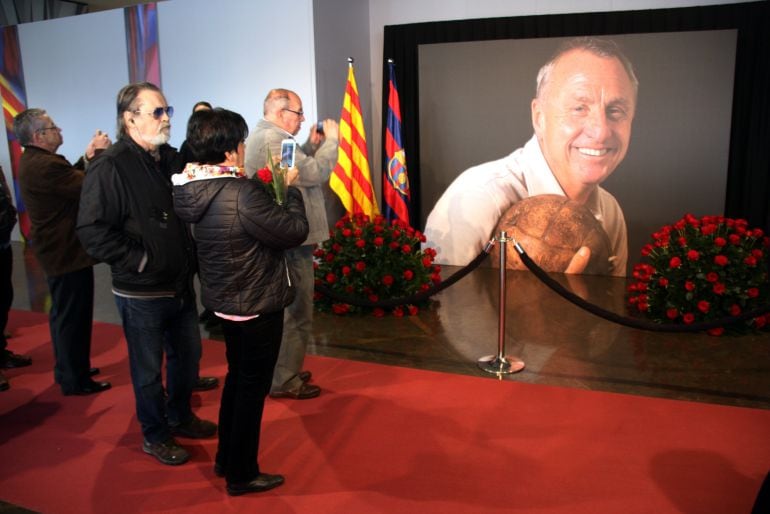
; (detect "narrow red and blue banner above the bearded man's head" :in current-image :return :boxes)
[125,3,161,87]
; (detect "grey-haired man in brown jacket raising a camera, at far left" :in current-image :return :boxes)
[13,109,110,396]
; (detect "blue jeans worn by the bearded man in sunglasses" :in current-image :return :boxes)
[115,294,201,443]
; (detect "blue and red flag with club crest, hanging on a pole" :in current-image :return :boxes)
[382,61,411,224]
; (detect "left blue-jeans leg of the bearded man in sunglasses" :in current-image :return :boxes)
[115,295,175,444]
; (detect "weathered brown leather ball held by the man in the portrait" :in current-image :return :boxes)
[491,195,611,275]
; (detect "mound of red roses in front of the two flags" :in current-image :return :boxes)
[314,210,441,317]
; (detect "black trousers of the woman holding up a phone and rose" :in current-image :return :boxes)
[216,310,283,484]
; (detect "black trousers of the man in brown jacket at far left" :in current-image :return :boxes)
[47,266,94,393]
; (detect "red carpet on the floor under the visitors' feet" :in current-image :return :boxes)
[0,311,770,514]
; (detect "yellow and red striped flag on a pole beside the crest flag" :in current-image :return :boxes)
[329,60,380,217]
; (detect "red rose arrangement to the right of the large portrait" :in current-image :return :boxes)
[628,214,770,335]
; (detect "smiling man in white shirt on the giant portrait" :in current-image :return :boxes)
[425,38,638,276]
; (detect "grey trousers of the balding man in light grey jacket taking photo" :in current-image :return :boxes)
[271,245,315,393]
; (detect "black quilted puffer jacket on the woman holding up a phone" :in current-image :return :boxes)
[174,167,308,316]
